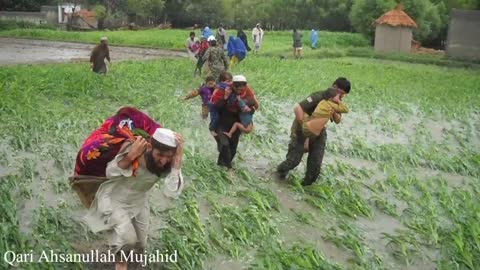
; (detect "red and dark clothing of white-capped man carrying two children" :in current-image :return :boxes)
[212,86,258,168]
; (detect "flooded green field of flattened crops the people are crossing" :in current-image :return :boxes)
[0,57,480,270]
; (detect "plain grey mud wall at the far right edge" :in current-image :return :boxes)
[446,9,480,60]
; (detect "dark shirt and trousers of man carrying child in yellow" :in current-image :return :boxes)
[277,89,337,185]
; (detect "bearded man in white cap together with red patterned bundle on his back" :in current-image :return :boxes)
[70,107,184,270]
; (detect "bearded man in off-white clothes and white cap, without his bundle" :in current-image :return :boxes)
[79,128,184,270]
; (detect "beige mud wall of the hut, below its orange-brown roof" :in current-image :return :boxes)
[375,24,412,52]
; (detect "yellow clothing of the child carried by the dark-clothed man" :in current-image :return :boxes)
[302,100,348,138]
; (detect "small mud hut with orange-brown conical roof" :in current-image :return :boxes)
[375,4,417,52]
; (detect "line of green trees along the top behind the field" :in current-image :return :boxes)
[0,0,480,46]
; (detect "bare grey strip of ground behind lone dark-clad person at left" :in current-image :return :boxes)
[0,38,187,65]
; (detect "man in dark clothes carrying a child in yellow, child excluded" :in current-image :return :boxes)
[277,77,350,186]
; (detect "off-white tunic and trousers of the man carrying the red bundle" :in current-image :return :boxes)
[85,146,183,252]
